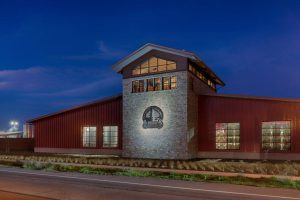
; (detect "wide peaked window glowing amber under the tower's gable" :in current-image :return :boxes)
[132,57,176,75]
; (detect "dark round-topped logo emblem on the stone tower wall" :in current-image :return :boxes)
[143,106,164,129]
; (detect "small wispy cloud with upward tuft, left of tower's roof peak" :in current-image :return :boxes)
[63,41,126,61]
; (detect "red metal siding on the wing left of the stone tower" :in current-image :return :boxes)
[31,97,122,149]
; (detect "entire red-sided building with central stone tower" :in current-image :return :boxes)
[26,44,300,160]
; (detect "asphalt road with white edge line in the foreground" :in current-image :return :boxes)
[0,167,300,200]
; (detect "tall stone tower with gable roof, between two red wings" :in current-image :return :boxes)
[113,44,224,159]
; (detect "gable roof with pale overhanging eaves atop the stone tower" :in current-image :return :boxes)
[112,43,225,86]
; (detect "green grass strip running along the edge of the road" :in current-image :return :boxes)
[9,162,300,189]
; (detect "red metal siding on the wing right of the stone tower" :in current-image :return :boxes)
[198,96,300,153]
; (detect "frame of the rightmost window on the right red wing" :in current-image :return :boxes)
[260,119,293,153]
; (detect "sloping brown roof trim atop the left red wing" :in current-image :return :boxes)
[26,94,122,123]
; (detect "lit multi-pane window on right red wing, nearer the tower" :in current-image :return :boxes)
[216,123,240,150]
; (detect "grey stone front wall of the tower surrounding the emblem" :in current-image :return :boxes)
[123,71,193,159]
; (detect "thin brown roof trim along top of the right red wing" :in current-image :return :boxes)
[199,94,300,103]
